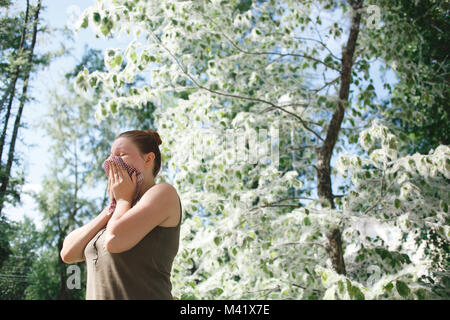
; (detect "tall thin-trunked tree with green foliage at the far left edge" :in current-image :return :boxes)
[0,0,52,214]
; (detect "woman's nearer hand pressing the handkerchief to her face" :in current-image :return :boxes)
[109,162,137,203]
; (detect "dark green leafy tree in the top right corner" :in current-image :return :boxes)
[374,0,450,154]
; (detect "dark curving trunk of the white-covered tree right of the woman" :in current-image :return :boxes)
[316,0,363,275]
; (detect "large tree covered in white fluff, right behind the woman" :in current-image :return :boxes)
[76,0,448,299]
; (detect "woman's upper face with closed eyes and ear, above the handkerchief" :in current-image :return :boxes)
[111,137,153,173]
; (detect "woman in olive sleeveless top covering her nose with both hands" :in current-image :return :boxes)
[60,130,182,300]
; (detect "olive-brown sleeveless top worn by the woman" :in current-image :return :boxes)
[84,196,183,300]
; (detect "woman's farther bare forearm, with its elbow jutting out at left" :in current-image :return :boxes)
[60,207,111,263]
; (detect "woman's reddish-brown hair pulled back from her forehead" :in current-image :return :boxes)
[116,130,162,177]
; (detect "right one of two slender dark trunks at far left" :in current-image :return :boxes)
[0,0,41,215]
